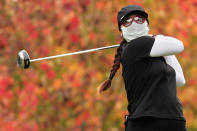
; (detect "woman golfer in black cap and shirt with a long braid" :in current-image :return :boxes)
[99,5,186,131]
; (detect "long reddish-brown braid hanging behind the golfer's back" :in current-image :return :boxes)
[98,40,126,93]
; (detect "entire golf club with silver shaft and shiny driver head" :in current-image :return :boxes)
[17,44,119,69]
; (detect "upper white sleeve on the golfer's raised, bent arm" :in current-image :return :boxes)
[150,35,184,57]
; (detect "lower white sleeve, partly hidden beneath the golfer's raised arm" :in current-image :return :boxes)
[164,55,185,86]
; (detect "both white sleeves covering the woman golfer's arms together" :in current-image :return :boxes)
[150,35,185,86]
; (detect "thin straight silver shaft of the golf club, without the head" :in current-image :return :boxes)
[30,44,119,62]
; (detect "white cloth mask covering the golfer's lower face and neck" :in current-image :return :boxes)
[121,21,149,42]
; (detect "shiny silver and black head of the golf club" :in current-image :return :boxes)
[17,50,30,69]
